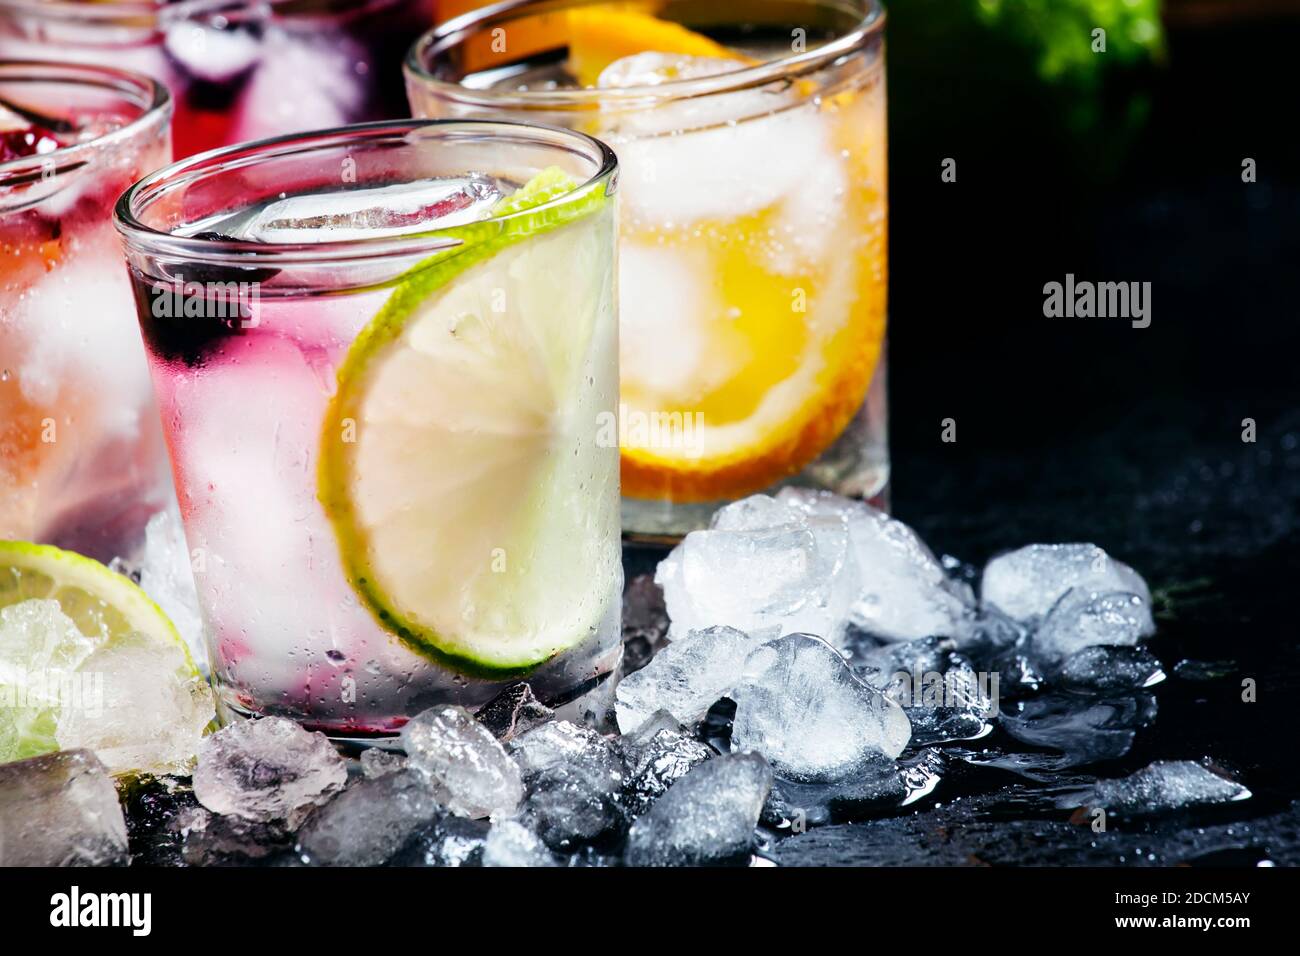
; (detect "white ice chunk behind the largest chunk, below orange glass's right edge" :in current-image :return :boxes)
[776,488,975,641]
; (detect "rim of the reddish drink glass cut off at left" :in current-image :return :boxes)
[0,60,173,189]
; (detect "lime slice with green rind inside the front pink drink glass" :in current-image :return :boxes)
[319,169,621,678]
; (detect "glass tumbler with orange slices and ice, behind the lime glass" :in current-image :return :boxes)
[406,0,889,538]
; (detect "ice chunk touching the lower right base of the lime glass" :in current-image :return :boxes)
[614,627,762,734]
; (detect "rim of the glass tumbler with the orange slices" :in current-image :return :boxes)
[402,0,885,109]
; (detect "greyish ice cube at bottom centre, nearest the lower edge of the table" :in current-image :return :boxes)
[624,753,772,866]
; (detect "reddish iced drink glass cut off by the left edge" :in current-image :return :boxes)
[0,61,172,561]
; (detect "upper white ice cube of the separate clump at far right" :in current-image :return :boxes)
[980,544,1156,636]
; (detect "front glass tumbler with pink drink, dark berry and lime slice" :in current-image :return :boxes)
[117,121,623,739]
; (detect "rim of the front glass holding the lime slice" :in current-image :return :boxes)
[113,120,619,267]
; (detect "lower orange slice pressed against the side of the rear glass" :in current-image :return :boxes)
[620,204,885,502]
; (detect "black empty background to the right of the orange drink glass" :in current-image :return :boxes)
[863,0,1300,862]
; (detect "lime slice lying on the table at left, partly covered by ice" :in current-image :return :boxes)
[0,541,203,762]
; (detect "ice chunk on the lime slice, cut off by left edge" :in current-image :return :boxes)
[0,598,95,763]
